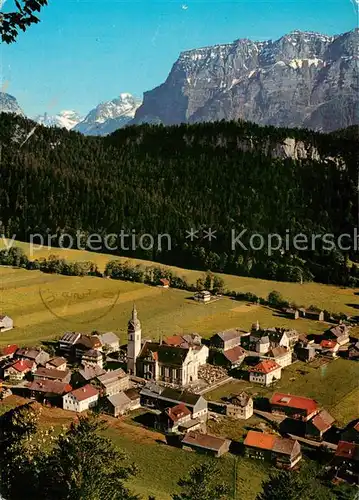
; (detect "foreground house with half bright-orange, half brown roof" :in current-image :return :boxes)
[244,431,302,469]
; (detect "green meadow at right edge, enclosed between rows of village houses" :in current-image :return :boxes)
[206,358,359,426]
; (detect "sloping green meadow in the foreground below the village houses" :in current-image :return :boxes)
[0,396,271,500]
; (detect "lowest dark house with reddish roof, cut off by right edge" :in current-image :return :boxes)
[332,441,359,483]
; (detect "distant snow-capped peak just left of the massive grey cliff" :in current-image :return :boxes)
[74,93,141,135]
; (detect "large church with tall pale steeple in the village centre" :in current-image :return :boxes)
[127,306,209,387]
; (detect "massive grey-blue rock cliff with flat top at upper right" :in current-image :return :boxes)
[134,29,359,131]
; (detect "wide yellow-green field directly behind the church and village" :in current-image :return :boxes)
[0,267,353,345]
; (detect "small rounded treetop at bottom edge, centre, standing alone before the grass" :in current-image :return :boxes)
[172,462,229,500]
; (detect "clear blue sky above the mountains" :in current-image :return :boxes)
[0,0,358,116]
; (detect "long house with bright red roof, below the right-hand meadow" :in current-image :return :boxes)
[270,392,319,422]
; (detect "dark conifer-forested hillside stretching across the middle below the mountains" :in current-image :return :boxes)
[0,114,358,286]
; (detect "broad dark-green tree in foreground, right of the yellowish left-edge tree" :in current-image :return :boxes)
[42,415,138,500]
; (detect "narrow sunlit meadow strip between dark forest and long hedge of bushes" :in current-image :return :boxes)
[0,240,359,314]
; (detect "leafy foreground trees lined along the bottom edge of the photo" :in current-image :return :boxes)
[0,403,356,500]
